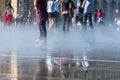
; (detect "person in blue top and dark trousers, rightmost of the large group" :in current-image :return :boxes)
[82,0,94,29]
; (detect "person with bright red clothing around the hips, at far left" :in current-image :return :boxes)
[2,2,14,25]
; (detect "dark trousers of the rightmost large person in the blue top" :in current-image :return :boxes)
[83,13,94,28]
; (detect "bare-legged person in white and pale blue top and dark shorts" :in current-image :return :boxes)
[47,0,55,29]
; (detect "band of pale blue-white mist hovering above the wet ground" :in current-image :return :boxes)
[0,25,120,56]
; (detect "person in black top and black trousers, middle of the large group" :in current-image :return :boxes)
[61,0,75,32]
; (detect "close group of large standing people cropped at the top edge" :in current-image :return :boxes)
[34,0,94,42]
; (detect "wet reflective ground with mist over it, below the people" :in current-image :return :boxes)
[0,27,120,80]
